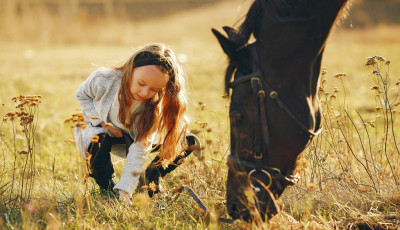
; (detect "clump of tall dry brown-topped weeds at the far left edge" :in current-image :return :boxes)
[0,95,42,211]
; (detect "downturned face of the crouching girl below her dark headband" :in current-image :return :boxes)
[130,65,169,101]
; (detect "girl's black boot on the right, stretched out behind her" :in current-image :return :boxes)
[139,134,201,197]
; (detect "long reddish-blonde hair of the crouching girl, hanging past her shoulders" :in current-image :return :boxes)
[114,43,189,161]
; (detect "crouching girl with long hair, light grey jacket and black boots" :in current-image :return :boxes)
[75,44,200,204]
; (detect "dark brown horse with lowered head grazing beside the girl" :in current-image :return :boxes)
[213,0,347,221]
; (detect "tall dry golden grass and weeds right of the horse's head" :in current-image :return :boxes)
[283,56,400,229]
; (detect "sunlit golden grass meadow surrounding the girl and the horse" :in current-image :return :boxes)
[0,0,400,229]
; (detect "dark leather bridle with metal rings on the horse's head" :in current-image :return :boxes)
[228,47,322,191]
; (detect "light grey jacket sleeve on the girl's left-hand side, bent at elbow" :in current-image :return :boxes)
[75,71,105,126]
